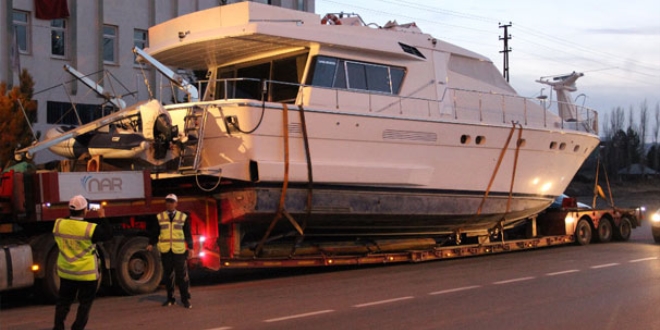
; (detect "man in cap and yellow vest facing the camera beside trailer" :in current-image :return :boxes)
[147,194,193,308]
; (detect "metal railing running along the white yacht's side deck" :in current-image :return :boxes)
[191,78,598,134]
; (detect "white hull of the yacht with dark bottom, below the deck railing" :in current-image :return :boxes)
[164,101,599,235]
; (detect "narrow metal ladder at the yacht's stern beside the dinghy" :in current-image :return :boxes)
[179,106,208,173]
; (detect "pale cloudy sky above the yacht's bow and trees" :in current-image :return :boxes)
[315,0,660,133]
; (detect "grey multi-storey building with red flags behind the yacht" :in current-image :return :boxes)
[0,0,314,163]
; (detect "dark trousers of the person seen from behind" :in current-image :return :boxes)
[53,278,97,330]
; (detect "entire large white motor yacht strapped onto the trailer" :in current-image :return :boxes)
[20,2,599,244]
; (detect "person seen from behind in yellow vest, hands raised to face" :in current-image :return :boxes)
[53,195,112,330]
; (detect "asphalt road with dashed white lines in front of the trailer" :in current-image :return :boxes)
[0,224,660,330]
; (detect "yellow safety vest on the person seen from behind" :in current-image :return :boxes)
[53,219,99,281]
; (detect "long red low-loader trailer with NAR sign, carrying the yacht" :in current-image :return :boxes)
[0,171,641,299]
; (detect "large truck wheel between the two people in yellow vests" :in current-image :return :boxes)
[115,237,163,295]
